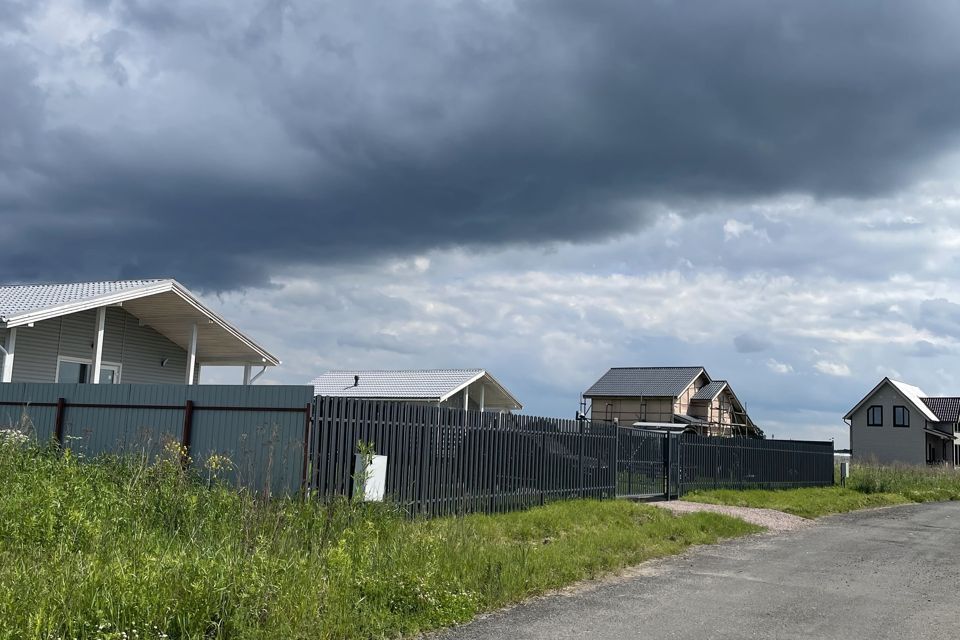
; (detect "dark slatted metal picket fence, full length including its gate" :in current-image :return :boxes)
[308,397,833,515]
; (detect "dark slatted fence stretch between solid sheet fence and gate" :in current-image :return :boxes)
[309,398,617,515]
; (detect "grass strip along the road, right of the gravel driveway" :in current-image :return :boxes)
[683,465,960,518]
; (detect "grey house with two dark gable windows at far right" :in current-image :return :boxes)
[843,378,960,467]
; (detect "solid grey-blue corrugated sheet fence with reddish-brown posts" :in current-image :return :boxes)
[0,383,313,493]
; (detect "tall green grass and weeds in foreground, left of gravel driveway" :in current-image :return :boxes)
[0,442,757,640]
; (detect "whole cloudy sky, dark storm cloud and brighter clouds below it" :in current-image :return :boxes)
[0,0,960,445]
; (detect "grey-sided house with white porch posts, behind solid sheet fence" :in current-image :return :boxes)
[0,279,280,384]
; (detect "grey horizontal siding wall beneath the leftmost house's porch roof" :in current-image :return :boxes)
[13,307,187,384]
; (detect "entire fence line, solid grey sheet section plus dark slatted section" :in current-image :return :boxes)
[0,383,833,508]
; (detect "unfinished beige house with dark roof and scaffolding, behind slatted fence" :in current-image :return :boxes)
[583,367,763,437]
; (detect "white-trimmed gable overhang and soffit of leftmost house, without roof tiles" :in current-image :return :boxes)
[0,279,280,366]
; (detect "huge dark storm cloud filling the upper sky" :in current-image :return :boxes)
[0,0,960,289]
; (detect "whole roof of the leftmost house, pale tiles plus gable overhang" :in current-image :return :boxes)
[0,279,280,366]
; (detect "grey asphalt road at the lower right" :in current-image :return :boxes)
[439,502,960,640]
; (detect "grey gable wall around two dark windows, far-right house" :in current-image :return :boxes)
[850,384,927,464]
